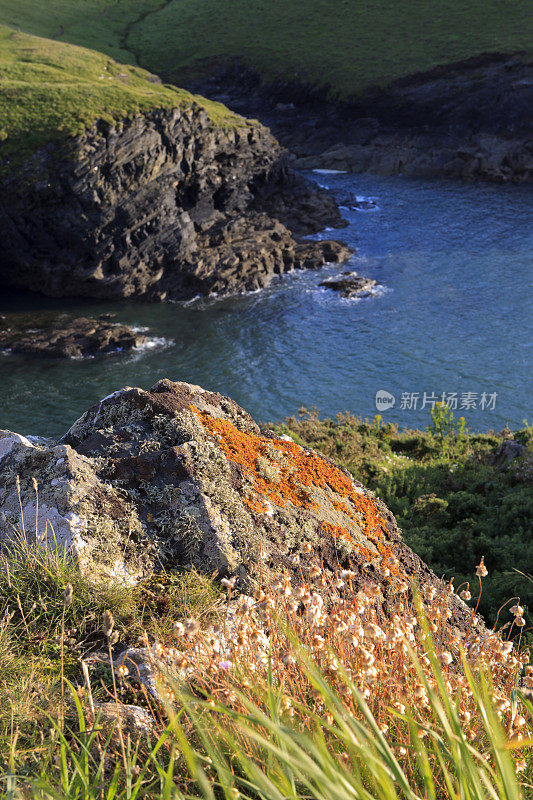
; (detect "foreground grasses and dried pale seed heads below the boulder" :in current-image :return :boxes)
[0,528,533,800]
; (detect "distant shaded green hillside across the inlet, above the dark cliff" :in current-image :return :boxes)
[0,0,533,101]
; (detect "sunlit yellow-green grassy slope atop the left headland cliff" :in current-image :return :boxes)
[0,27,238,164]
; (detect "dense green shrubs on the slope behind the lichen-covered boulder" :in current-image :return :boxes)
[277,406,533,624]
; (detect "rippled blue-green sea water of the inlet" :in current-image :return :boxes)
[0,174,533,435]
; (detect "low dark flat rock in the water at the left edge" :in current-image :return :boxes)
[0,315,147,358]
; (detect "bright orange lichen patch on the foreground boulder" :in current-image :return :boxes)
[191,405,400,576]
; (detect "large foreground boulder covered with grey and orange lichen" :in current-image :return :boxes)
[0,380,444,588]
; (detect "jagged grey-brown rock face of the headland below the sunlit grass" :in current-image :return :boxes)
[0,103,348,300]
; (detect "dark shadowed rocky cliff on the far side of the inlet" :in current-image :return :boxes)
[196,53,533,183]
